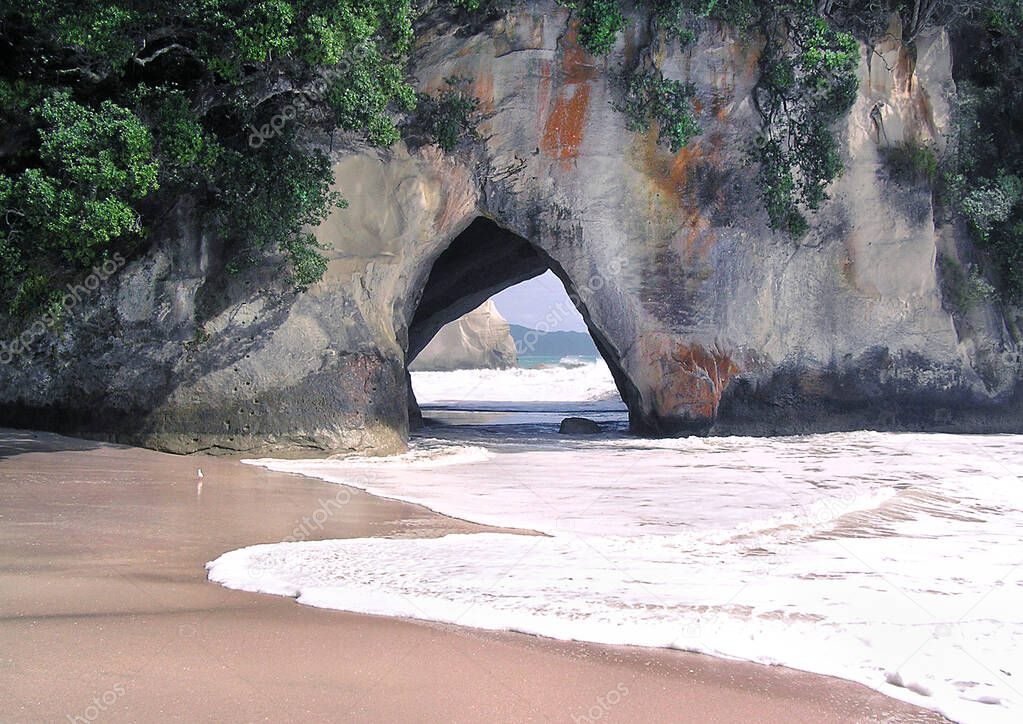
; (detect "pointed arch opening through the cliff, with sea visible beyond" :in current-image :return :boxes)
[406,217,628,429]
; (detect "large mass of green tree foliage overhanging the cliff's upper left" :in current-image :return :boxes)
[0,0,415,319]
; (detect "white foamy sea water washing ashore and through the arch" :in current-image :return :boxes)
[209,363,1023,722]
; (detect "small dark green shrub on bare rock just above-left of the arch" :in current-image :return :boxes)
[403,77,481,152]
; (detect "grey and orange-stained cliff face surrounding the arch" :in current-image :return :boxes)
[0,2,1021,452]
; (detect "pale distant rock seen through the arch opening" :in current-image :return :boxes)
[409,300,518,370]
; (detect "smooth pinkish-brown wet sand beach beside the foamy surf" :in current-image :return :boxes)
[0,429,943,722]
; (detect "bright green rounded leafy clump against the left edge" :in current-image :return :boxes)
[0,92,159,314]
